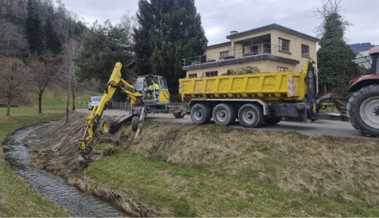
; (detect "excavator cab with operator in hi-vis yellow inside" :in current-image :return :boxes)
[134,75,170,112]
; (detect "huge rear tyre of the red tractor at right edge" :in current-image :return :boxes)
[348,85,379,136]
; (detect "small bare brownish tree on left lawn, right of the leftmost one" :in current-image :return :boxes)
[28,54,61,114]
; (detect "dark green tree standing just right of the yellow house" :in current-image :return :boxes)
[318,0,357,93]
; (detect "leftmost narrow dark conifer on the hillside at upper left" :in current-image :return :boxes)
[25,0,44,55]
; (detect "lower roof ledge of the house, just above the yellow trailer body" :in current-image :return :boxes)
[184,54,299,70]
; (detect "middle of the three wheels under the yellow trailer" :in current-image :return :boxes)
[213,104,237,126]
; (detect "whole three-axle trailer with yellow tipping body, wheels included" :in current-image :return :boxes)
[179,64,317,128]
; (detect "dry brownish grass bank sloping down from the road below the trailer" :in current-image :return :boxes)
[128,121,379,204]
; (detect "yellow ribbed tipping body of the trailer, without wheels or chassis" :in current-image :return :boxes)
[180,72,306,101]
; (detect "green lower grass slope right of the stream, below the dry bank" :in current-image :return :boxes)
[85,150,379,217]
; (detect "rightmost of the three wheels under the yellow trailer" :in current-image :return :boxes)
[238,104,263,128]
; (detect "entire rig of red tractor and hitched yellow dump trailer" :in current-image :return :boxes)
[180,48,379,136]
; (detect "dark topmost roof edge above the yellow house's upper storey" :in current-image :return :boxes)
[227,23,320,42]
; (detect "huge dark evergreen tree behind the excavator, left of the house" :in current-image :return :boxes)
[134,0,207,94]
